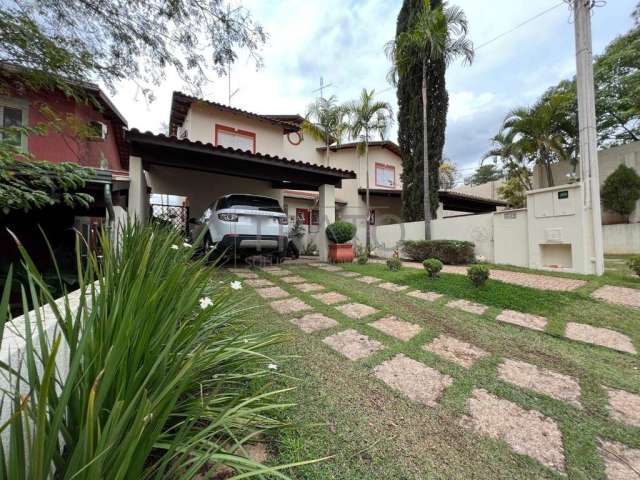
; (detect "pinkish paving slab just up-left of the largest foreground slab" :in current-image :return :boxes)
[374,354,453,407]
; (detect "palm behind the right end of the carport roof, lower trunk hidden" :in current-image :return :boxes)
[302,95,347,166]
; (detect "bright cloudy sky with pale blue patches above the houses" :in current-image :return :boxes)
[114,0,637,180]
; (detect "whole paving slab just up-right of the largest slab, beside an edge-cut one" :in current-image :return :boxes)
[498,359,582,408]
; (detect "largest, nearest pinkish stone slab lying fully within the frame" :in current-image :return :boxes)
[462,389,564,472]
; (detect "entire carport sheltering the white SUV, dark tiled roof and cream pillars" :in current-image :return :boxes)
[127,129,356,260]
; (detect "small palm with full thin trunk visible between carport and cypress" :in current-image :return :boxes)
[348,88,393,252]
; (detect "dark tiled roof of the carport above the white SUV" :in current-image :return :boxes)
[127,129,356,190]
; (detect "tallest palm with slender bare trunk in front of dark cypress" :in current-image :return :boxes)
[386,0,474,240]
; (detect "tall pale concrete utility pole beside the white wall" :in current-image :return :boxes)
[572,0,604,275]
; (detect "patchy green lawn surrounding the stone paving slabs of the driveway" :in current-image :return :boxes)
[232,264,640,479]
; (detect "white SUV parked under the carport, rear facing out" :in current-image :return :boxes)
[194,193,289,262]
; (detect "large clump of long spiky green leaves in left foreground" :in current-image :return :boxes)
[0,225,310,480]
